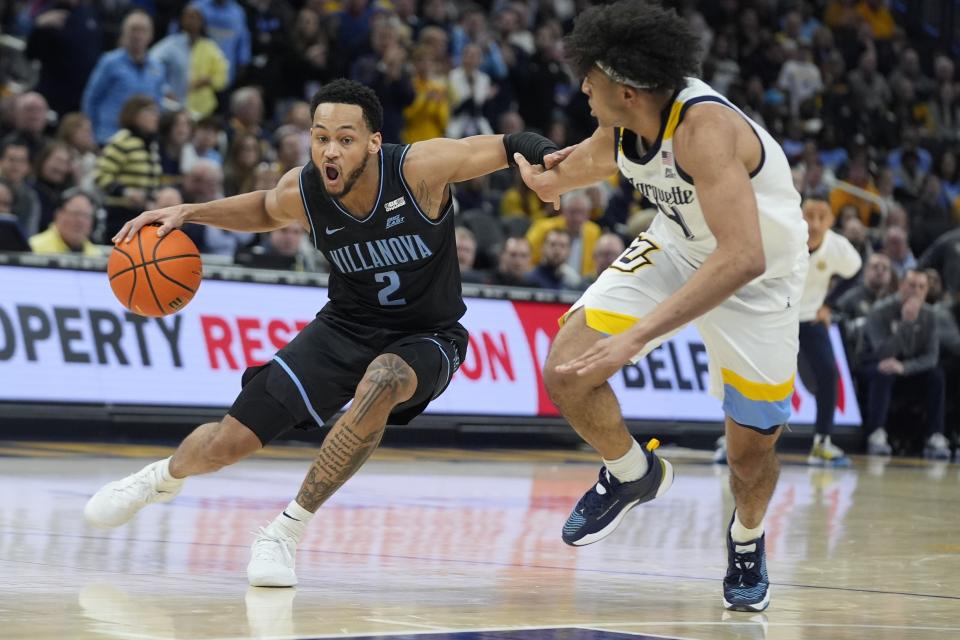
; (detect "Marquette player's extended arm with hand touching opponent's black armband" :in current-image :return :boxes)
[516,127,617,209]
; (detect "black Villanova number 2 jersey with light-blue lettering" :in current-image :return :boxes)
[300,144,466,331]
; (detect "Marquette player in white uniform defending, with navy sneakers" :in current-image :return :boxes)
[518,0,807,611]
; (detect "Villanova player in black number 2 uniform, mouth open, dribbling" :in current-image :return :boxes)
[84,80,556,586]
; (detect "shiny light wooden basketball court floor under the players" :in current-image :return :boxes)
[0,442,960,640]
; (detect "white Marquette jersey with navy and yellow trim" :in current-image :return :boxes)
[616,78,807,279]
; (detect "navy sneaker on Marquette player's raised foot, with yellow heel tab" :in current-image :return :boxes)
[563,438,673,547]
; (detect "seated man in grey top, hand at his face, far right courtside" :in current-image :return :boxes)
[864,269,950,460]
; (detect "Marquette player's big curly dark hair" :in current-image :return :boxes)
[564,0,701,89]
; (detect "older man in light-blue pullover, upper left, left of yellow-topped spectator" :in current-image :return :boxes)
[83,11,164,145]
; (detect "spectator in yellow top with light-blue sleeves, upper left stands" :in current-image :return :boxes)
[150,4,230,118]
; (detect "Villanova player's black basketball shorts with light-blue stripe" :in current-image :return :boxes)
[229,312,467,444]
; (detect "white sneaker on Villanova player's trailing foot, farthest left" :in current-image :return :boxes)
[83,460,183,529]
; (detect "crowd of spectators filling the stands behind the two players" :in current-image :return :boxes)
[0,0,960,456]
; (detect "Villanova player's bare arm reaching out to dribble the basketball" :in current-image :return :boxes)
[113,167,309,244]
